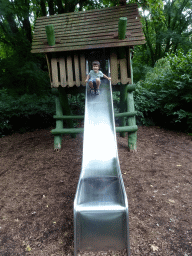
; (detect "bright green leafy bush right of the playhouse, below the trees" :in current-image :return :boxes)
[135,50,192,132]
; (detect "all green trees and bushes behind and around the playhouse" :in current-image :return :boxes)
[0,0,192,135]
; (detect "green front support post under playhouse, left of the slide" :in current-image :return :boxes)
[52,88,63,151]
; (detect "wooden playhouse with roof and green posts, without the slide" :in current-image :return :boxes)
[32,4,145,150]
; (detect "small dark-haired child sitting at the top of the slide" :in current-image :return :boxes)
[85,61,111,95]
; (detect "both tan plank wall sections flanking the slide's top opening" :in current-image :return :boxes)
[50,48,131,87]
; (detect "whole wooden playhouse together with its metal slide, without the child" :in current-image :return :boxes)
[32,4,145,256]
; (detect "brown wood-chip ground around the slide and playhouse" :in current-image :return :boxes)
[0,127,192,256]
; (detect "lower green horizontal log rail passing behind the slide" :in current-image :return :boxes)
[51,125,138,135]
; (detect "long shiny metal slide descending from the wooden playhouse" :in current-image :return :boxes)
[74,61,129,256]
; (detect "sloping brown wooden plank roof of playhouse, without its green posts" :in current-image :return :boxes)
[31,4,145,53]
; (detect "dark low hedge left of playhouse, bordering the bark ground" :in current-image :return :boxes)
[0,89,55,136]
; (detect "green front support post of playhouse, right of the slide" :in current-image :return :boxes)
[127,50,137,152]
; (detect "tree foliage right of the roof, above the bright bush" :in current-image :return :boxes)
[131,0,192,67]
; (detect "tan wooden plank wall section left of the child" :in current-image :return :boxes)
[50,54,86,87]
